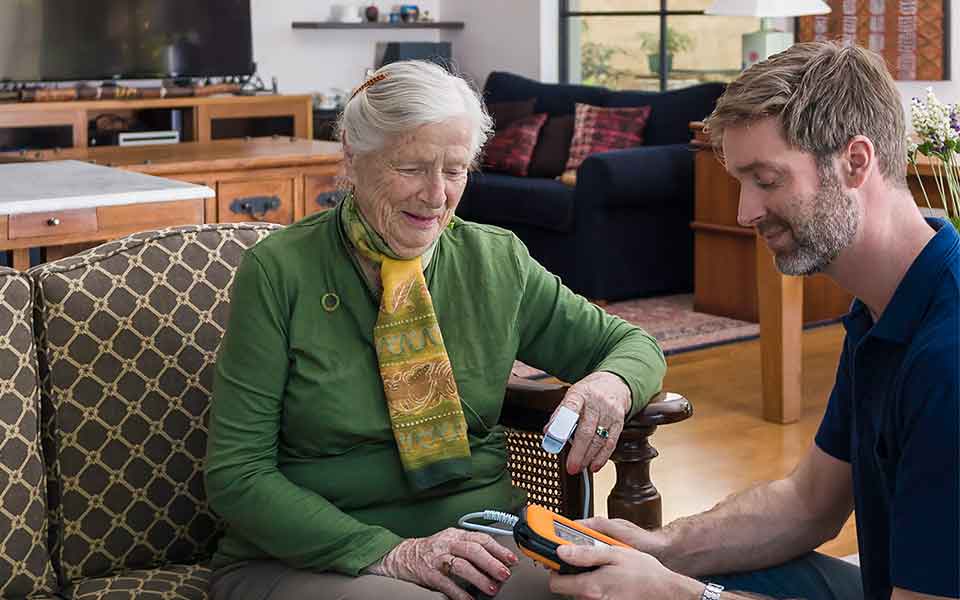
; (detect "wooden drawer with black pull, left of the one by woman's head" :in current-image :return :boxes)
[217,179,293,225]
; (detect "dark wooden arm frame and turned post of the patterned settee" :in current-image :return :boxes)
[501,377,693,529]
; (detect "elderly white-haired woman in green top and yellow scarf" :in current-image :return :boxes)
[206,62,665,600]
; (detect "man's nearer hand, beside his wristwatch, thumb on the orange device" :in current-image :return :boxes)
[550,545,704,600]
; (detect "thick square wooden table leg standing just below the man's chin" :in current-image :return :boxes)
[756,236,803,423]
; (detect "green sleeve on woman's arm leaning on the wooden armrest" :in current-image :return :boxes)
[515,240,667,416]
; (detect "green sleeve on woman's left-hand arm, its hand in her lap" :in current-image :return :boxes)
[205,249,402,575]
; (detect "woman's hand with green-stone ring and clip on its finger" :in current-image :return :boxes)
[543,371,631,475]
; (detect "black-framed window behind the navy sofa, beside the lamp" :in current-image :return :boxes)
[560,0,760,91]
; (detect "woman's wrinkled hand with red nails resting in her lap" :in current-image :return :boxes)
[366,527,517,600]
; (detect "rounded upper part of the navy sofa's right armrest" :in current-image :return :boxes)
[577,144,694,210]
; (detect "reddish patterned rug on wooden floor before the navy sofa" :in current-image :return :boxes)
[513,294,760,379]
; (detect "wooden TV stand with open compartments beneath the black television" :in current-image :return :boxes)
[0,95,313,151]
